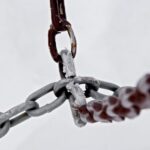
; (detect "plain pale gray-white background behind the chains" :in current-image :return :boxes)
[0,0,150,150]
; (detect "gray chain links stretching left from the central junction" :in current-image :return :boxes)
[0,83,66,138]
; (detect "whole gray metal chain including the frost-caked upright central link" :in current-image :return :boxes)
[0,50,119,138]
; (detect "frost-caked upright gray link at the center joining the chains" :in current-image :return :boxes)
[59,50,86,127]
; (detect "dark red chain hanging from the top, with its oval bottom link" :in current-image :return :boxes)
[48,0,77,62]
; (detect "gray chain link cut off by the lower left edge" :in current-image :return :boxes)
[0,113,10,138]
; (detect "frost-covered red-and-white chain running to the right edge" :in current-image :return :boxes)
[78,74,150,123]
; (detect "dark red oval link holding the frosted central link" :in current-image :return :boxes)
[48,24,77,62]
